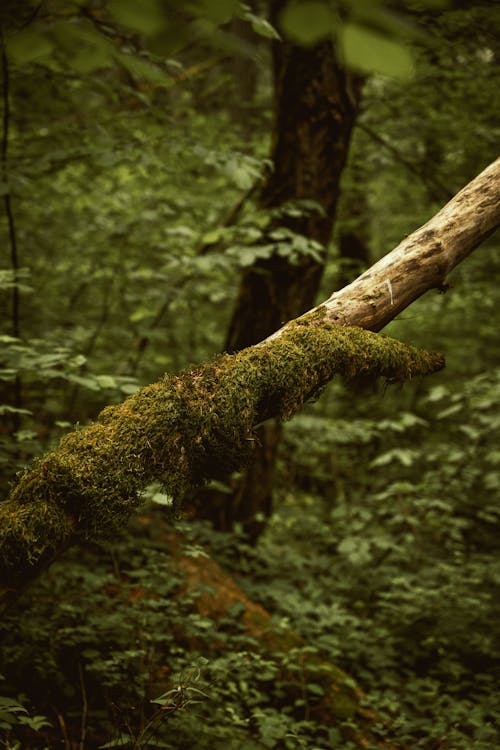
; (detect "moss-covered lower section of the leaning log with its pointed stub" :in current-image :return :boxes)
[0,322,443,601]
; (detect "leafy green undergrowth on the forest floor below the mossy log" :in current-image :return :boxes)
[0,372,500,750]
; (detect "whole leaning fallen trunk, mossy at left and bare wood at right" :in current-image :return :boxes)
[0,159,500,604]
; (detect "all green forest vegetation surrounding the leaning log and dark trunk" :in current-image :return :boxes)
[0,0,500,750]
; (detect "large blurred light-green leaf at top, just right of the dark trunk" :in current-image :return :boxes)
[340,23,413,79]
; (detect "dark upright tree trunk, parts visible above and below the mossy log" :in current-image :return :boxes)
[197,25,361,538]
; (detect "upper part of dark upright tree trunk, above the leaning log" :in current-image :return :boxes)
[226,42,360,352]
